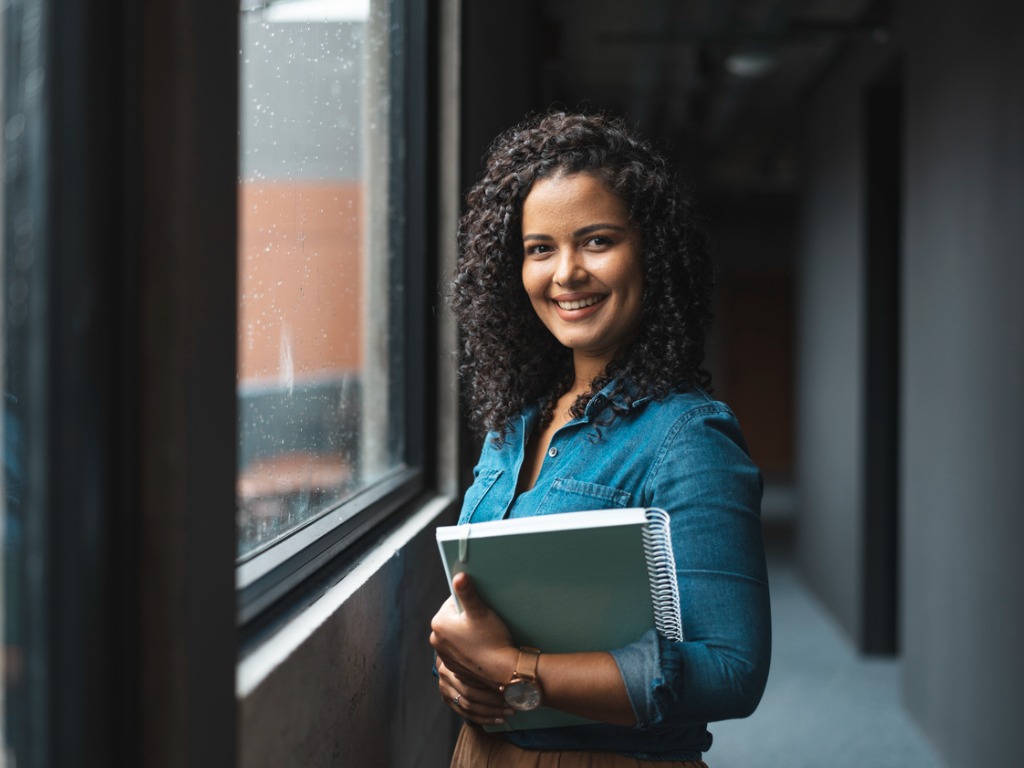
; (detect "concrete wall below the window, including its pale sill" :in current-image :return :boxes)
[238,502,458,768]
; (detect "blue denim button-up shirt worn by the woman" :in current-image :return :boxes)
[459,385,771,761]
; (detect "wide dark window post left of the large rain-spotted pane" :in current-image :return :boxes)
[4,0,239,768]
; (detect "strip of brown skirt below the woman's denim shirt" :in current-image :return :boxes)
[452,724,708,768]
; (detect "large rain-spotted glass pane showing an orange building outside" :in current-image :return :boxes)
[238,0,403,558]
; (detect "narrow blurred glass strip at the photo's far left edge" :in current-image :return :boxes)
[0,0,42,766]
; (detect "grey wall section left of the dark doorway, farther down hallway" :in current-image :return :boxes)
[797,45,880,651]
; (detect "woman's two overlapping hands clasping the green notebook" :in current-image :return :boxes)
[430,573,518,724]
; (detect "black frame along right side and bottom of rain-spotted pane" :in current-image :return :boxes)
[236,0,437,626]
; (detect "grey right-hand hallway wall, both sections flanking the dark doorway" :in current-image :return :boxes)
[798,0,1024,765]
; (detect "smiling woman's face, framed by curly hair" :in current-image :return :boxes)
[522,173,643,369]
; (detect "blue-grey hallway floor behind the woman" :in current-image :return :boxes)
[705,547,946,768]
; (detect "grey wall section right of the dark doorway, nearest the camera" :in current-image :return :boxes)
[901,0,1024,765]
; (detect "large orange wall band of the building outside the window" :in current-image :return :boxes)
[239,181,365,382]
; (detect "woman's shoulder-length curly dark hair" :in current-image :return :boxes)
[449,112,713,442]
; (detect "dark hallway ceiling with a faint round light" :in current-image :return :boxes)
[540,0,892,191]
